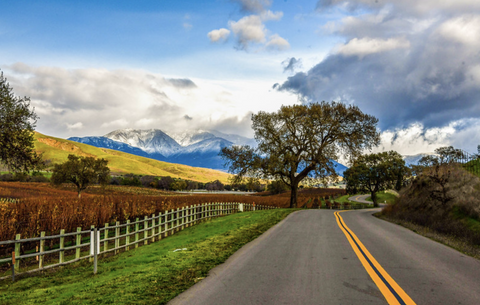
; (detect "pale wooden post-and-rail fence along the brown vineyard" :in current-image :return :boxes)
[0,203,277,280]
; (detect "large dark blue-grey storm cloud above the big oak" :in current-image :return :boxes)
[276,0,480,129]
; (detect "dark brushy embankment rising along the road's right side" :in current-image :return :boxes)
[380,147,480,258]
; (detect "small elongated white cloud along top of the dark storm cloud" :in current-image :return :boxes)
[337,37,410,58]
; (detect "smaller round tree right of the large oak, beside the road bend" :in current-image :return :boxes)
[343,151,409,206]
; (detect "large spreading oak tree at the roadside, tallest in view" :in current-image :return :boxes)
[220,102,379,207]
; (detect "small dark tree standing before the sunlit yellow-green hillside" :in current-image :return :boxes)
[51,155,110,198]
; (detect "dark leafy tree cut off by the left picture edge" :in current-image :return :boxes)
[0,72,41,172]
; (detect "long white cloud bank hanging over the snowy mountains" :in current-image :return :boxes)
[2,64,296,138]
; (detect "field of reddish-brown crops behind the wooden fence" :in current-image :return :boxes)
[0,182,344,240]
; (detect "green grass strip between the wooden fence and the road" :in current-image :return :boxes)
[0,209,295,305]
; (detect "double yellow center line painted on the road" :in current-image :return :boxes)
[334,211,415,305]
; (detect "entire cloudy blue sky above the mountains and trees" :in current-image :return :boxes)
[0,0,480,155]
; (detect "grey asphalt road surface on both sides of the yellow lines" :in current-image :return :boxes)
[171,209,480,305]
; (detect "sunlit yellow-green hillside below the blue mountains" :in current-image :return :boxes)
[35,132,230,183]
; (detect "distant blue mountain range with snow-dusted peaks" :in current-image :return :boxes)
[68,129,347,175]
